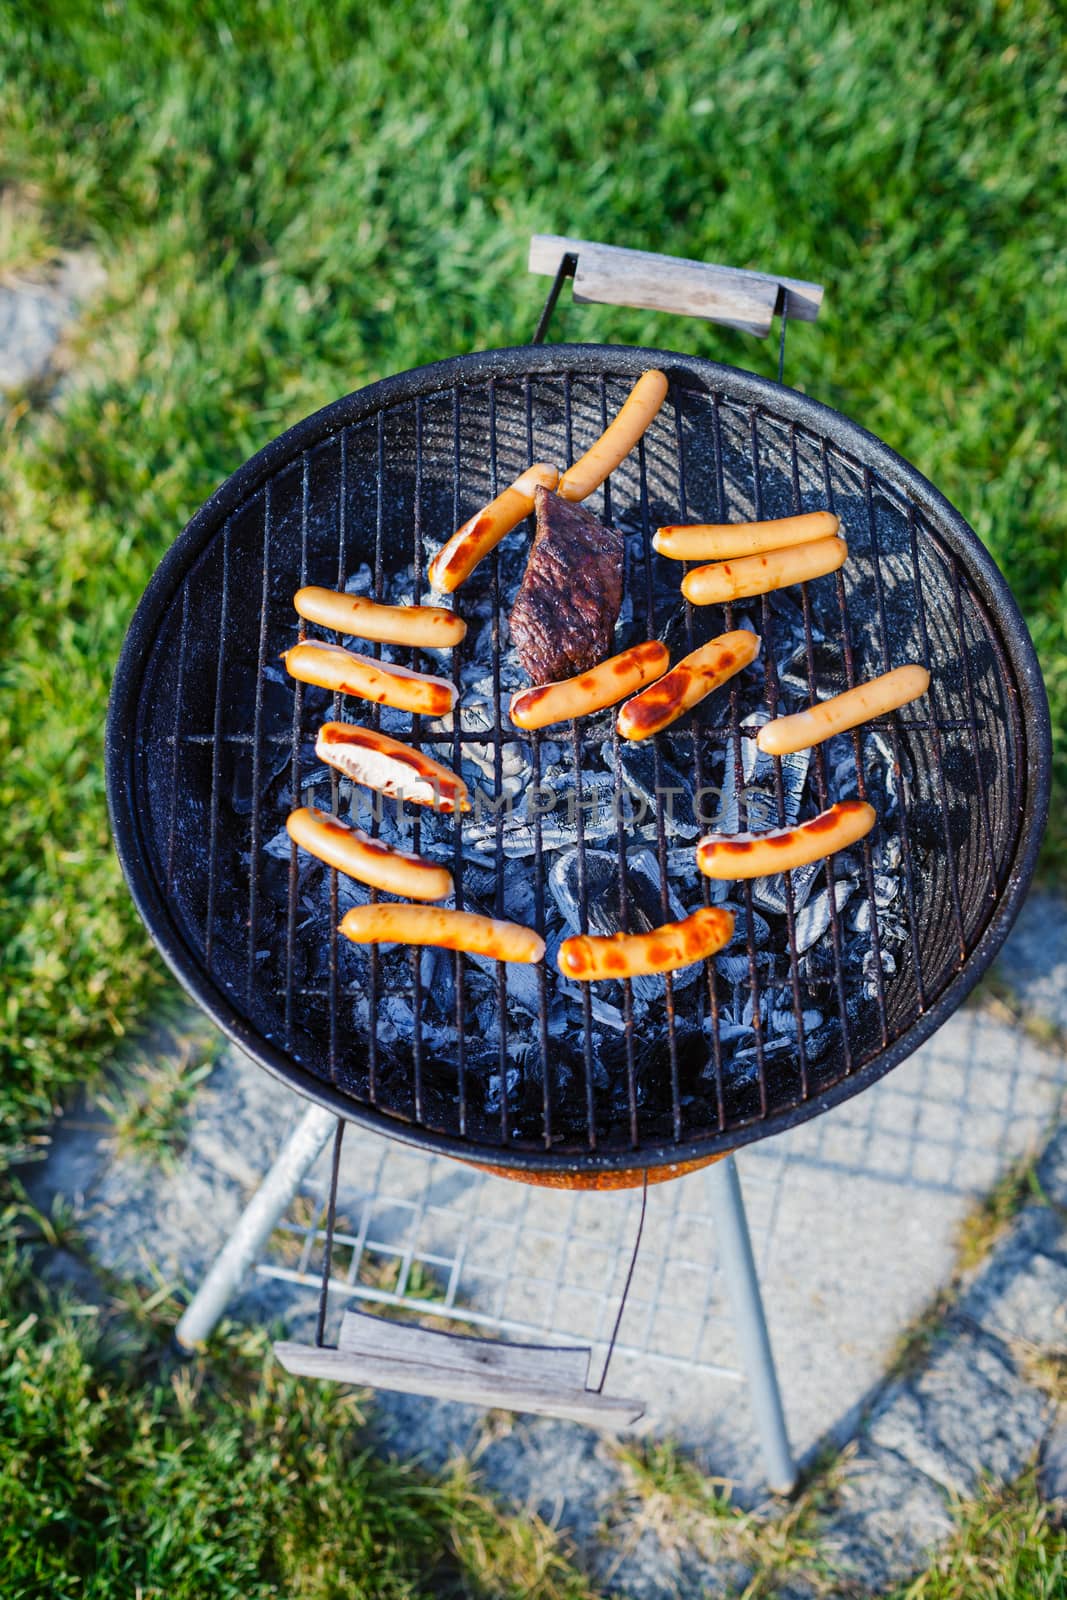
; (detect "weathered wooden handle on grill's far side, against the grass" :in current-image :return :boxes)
[530,234,822,339]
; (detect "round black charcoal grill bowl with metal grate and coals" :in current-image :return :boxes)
[107,240,1051,1484]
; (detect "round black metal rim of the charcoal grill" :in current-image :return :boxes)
[104,344,1053,1174]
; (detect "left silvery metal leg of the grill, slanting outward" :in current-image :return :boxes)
[174,1106,338,1354]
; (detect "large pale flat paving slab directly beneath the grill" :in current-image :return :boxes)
[33,1011,1067,1510]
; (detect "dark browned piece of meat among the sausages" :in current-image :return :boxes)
[510,488,622,683]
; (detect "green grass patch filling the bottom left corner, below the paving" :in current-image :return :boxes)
[0,1219,589,1600]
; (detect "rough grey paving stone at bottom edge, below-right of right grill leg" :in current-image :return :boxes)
[812,1442,953,1592]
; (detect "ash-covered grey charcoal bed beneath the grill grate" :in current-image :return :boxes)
[254,518,910,1132]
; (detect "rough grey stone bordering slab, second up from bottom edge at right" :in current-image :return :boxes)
[867,1320,1049,1498]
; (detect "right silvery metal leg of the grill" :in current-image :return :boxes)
[704,1155,797,1494]
